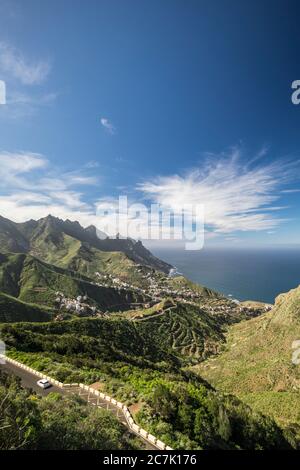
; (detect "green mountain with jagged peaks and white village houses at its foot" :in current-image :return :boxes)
[0,216,220,320]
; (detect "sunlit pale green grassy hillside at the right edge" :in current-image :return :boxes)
[196,287,300,434]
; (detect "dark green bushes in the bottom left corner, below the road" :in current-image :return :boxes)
[0,371,140,450]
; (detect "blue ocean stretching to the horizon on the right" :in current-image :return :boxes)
[151,247,300,303]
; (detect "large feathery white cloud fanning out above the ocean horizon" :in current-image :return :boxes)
[138,148,298,233]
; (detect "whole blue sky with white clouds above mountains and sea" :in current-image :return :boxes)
[0,0,300,245]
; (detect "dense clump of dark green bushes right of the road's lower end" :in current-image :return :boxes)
[138,382,291,450]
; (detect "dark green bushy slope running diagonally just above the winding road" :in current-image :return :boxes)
[2,318,295,449]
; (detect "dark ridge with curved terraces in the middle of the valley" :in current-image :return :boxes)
[1,300,229,370]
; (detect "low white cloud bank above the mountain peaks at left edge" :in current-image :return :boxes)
[0,152,97,225]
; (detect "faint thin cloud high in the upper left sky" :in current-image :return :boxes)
[0,42,51,85]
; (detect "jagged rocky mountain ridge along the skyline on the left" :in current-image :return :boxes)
[0,215,172,273]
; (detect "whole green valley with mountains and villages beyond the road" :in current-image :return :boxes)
[0,216,300,449]
